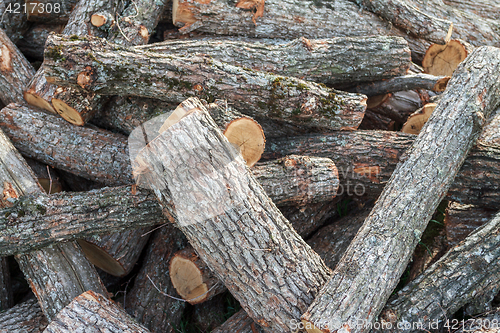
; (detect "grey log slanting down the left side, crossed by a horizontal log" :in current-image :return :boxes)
[0,127,107,320]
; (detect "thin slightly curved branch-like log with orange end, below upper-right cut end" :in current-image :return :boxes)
[349,74,450,96]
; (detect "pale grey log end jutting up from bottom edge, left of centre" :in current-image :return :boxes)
[44,291,150,333]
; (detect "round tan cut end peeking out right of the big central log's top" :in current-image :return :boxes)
[224,117,266,167]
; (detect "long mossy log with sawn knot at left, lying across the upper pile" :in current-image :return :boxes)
[43,35,366,129]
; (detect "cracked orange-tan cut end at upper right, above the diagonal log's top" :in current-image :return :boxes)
[422,40,468,76]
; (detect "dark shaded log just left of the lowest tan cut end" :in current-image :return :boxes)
[125,223,187,333]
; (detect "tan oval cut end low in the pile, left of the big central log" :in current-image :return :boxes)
[169,256,208,304]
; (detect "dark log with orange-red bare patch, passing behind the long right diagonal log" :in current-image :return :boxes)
[263,131,500,209]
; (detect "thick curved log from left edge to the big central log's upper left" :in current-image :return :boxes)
[0,104,133,185]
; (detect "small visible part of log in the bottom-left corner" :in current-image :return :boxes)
[0,299,48,333]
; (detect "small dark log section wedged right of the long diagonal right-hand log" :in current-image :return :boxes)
[444,202,495,246]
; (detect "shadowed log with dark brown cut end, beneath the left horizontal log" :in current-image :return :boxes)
[78,227,151,276]
